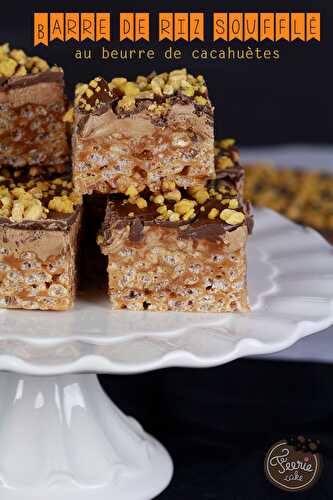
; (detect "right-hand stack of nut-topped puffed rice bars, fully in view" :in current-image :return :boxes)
[72,70,252,312]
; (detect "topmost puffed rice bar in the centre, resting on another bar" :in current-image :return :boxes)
[72,69,214,194]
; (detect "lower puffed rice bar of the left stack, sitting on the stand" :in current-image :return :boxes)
[0,167,82,310]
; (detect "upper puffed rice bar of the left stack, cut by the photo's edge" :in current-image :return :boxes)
[0,43,68,169]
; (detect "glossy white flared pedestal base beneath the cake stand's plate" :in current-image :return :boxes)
[0,373,173,500]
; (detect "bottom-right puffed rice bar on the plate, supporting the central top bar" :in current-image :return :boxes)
[98,180,252,312]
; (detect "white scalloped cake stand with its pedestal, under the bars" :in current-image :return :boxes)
[0,210,333,500]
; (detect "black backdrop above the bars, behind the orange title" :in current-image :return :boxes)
[0,0,333,145]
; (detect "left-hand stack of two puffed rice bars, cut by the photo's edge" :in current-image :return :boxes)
[0,44,82,310]
